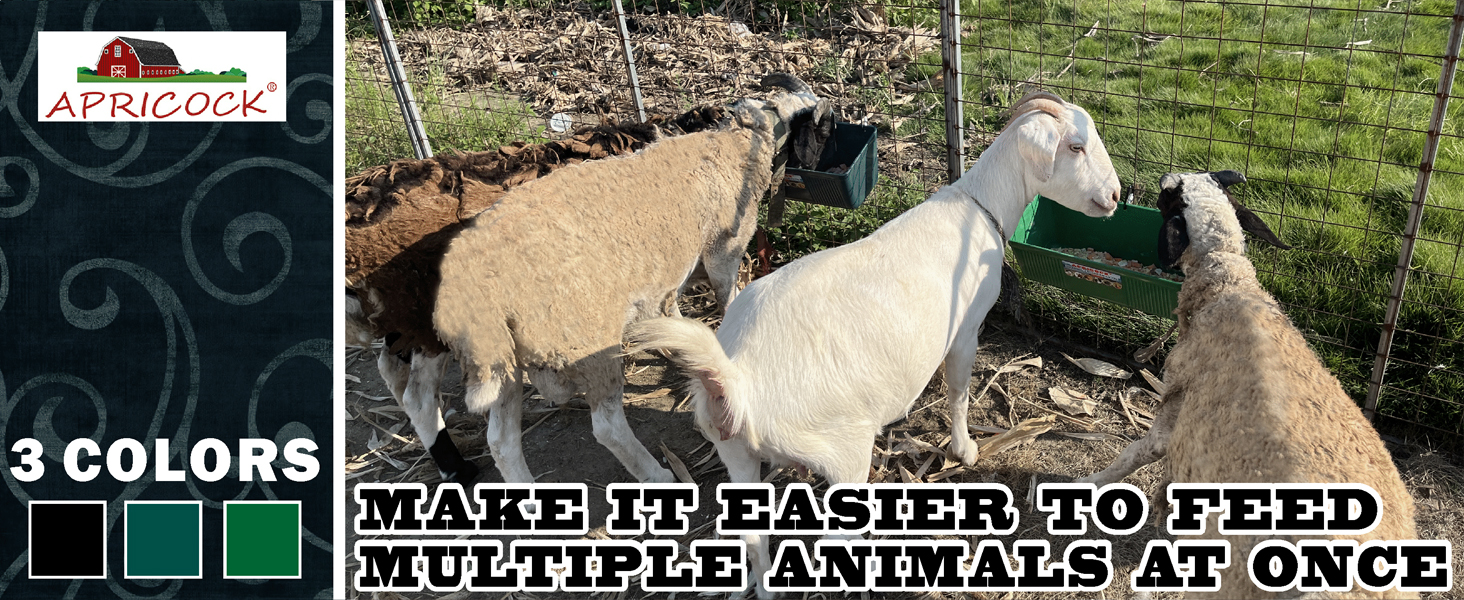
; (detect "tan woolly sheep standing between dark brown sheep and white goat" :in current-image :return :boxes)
[433,95,807,483]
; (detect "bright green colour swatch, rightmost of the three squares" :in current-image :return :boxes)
[224,502,300,578]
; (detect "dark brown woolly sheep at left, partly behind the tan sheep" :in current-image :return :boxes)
[346,122,664,483]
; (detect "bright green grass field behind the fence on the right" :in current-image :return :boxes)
[918,0,1464,430]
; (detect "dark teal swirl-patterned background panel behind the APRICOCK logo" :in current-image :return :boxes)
[0,1,340,600]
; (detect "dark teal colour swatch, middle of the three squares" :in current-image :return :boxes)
[126,502,203,580]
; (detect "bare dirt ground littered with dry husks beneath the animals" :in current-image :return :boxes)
[344,286,1464,600]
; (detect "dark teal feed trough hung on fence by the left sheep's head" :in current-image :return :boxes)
[783,123,880,209]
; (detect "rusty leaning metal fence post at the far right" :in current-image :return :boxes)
[1363,0,1464,420]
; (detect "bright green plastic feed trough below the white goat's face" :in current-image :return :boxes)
[1012,196,1180,319]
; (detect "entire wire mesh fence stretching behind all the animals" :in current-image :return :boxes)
[347,0,1464,445]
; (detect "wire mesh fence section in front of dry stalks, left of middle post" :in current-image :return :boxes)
[347,0,946,258]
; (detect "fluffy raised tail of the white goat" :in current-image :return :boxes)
[627,318,757,446]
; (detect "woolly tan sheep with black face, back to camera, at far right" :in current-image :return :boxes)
[1079,171,1417,599]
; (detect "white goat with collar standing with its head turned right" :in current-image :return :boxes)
[631,92,1118,597]
